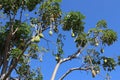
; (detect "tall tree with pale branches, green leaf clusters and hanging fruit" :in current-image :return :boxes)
[0,0,120,80]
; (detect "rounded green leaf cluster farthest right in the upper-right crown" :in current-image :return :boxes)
[101,29,117,45]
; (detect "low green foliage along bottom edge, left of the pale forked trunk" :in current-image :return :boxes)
[17,63,43,80]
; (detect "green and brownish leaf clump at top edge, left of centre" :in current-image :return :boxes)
[40,1,61,26]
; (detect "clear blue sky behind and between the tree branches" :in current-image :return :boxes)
[30,0,120,80]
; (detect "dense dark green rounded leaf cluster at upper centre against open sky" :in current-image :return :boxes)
[62,12,85,35]
